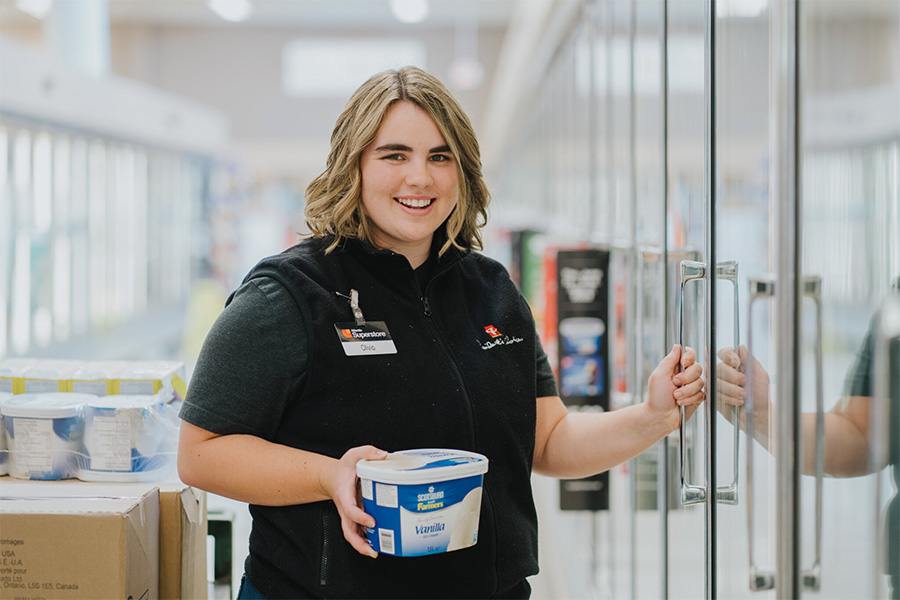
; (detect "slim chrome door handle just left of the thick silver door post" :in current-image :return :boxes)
[744,277,775,592]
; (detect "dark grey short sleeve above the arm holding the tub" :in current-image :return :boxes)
[180,277,308,440]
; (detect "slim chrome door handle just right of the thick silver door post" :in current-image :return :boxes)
[802,276,825,590]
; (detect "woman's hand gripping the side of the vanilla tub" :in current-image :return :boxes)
[321,446,387,558]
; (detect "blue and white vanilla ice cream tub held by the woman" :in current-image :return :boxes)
[356,448,488,556]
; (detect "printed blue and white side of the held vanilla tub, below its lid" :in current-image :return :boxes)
[360,475,483,556]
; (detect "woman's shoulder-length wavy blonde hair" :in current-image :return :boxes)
[306,67,490,254]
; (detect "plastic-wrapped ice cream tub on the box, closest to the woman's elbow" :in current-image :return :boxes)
[78,394,171,481]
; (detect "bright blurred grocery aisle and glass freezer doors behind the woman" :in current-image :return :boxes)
[0,0,900,598]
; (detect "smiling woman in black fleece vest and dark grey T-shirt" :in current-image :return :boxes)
[179,67,704,598]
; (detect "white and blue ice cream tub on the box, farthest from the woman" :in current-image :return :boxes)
[0,392,89,479]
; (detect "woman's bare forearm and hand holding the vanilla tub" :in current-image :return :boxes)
[178,421,387,557]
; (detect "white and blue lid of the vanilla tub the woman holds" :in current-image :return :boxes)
[356,448,488,485]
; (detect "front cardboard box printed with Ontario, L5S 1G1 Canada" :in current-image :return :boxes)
[0,482,159,600]
